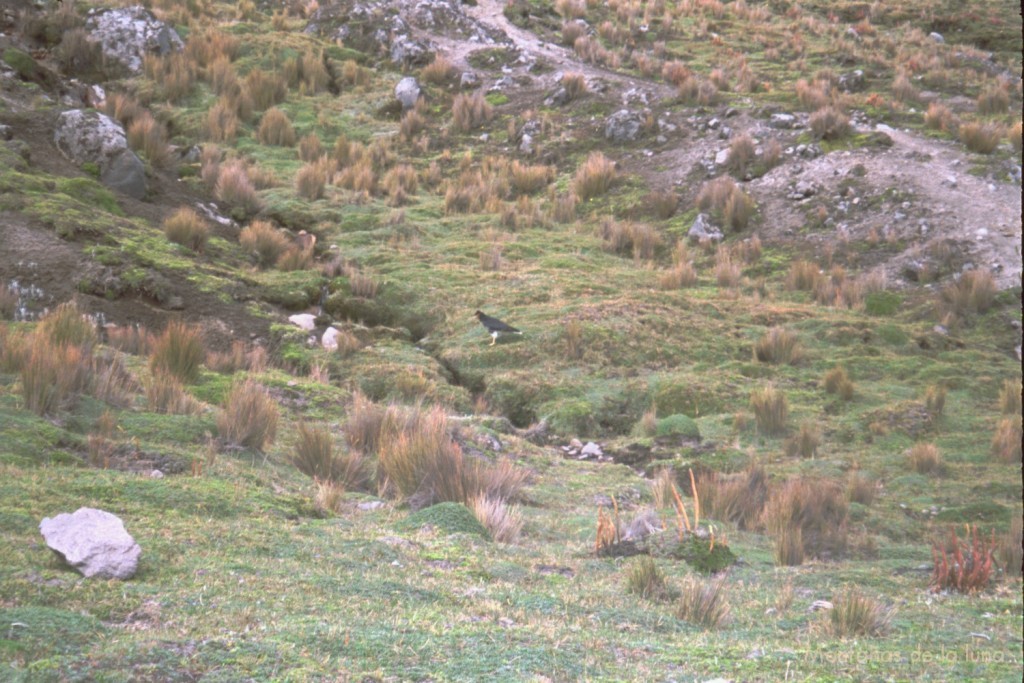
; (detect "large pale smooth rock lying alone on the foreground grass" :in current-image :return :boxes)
[39,508,142,579]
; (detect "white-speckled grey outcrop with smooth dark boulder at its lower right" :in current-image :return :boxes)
[53,110,145,199]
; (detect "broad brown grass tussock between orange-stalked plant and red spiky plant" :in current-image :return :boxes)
[764,478,848,565]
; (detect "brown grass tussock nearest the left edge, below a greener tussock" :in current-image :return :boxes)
[19,332,91,416]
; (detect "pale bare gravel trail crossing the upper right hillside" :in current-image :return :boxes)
[434,0,1022,289]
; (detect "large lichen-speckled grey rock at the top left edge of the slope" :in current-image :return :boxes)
[85,7,184,74]
